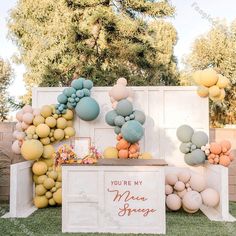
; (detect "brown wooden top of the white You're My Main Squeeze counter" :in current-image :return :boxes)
[62,158,168,166]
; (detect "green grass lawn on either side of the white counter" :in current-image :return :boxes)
[0,203,236,236]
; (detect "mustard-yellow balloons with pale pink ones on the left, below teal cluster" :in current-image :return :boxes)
[12,105,75,208]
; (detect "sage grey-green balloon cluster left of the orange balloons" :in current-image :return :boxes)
[176,125,208,166]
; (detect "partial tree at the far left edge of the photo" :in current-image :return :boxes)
[0,58,12,121]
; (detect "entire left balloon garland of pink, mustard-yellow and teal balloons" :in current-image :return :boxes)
[12,78,100,208]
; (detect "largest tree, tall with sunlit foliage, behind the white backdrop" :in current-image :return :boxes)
[9,0,178,102]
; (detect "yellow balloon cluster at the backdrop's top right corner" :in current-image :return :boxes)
[193,68,230,102]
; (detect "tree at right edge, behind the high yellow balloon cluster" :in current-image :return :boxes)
[185,21,236,126]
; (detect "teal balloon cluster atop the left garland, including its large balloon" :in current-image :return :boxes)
[56,77,100,121]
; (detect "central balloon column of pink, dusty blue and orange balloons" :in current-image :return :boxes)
[105,78,146,158]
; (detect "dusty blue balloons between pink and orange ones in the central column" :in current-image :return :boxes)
[105,78,146,143]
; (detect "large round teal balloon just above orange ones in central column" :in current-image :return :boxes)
[121,120,144,143]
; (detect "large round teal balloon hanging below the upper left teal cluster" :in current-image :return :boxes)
[75,97,100,121]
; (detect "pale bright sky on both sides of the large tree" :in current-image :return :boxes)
[0,0,236,97]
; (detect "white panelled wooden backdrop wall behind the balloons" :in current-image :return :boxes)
[33,86,209,166]
